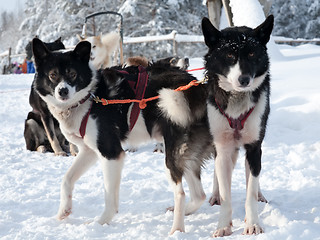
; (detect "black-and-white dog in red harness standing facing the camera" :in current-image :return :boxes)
[202,15,274,237]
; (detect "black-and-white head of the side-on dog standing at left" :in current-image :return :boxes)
[32,38,95,108]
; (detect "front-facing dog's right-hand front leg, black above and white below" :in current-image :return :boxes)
[243,144,263,235]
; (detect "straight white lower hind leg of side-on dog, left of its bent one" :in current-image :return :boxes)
[165,166,185,235]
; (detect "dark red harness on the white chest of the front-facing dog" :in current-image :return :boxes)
[214,99,254,140]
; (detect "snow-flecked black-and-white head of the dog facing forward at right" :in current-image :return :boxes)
[202,15,273,92]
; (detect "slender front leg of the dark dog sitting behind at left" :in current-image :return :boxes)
[41,115,67,156]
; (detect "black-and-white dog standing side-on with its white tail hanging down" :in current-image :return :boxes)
[33,39,212,234]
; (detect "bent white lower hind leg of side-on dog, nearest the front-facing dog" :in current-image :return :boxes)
[184,167,206,215]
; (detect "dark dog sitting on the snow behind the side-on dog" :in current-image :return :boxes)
[24,37,77,156]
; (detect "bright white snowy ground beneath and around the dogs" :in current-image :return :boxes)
[0,45,320,240]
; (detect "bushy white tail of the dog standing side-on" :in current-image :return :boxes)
[158,88,193,127]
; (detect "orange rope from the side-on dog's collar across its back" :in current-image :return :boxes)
[93,76,208,109]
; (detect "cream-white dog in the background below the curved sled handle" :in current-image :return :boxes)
[77,32,120,70]
